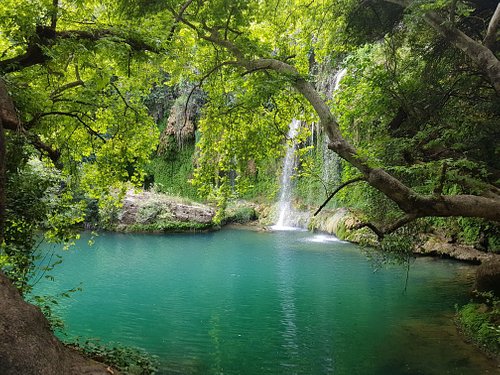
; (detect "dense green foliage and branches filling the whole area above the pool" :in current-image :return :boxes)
[0,0,500,370]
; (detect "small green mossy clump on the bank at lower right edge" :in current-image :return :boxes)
[456,293,500,357]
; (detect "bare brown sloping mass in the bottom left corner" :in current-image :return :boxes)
[0,272,117,375]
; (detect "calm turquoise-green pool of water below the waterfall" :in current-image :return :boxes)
[35,230,496,375]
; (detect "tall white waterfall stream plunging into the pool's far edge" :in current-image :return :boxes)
[272,119,300,230]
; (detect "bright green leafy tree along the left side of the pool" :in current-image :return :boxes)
[0,0,162,285]
